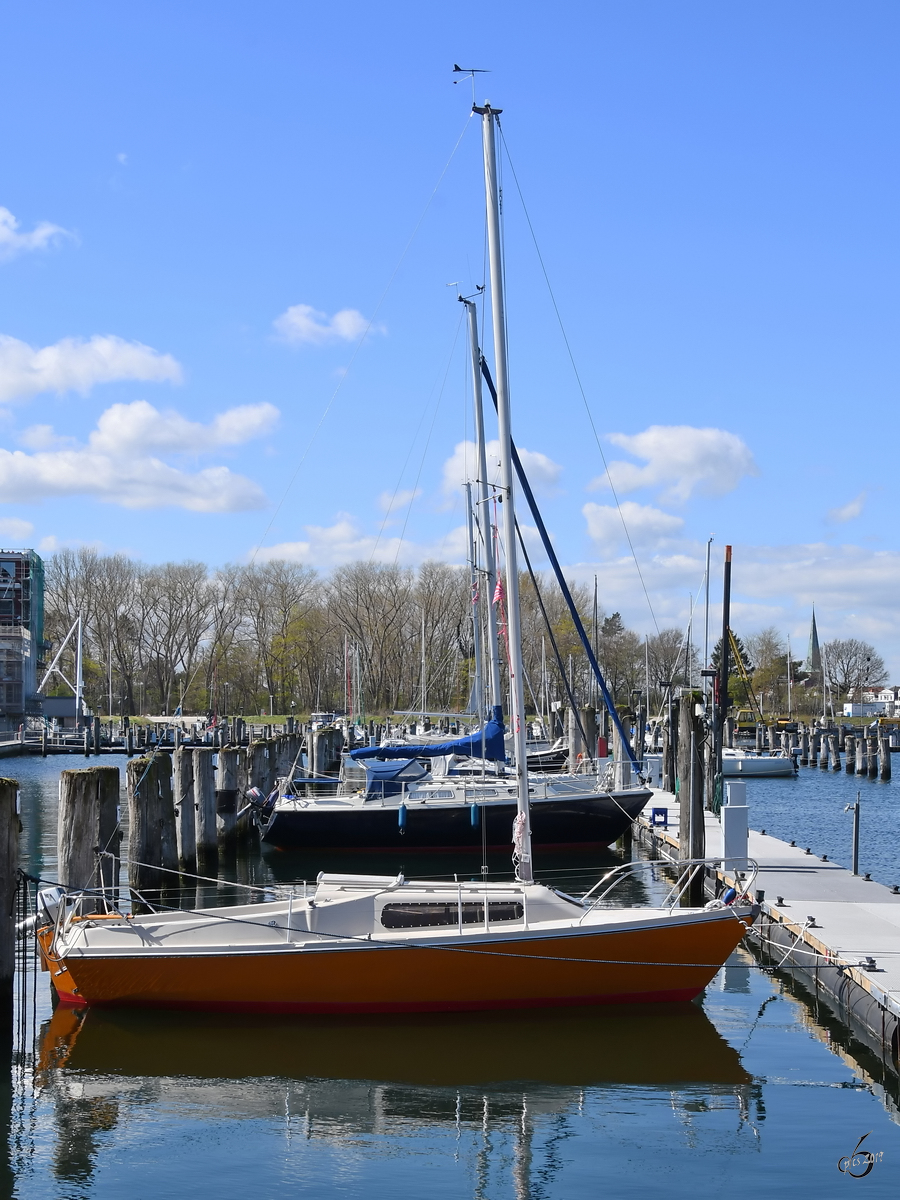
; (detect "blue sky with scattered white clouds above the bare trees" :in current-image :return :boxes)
[0,0,900,679]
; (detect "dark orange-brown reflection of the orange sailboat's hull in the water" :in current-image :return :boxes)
[38,1004,751,1087]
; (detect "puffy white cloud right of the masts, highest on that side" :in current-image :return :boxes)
[590,425,760,504]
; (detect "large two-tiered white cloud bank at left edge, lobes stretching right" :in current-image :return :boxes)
[0,401,278,512]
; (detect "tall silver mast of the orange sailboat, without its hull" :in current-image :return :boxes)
[475,101,534,882]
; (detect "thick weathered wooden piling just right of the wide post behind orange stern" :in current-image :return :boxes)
[125,754,178,893]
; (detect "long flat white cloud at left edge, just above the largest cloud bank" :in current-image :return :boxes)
[0,334,181,403]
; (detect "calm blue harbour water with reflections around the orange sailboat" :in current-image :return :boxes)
[0,758,900,1200]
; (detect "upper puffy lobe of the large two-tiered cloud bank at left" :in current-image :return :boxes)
[88,400,281,454]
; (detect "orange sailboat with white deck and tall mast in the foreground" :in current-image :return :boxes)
[38,104,756,1013]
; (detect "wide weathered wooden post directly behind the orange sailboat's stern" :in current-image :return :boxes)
[56,767,121,912]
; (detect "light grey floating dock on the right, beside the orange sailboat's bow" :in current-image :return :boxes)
[634,788,900,1072]
